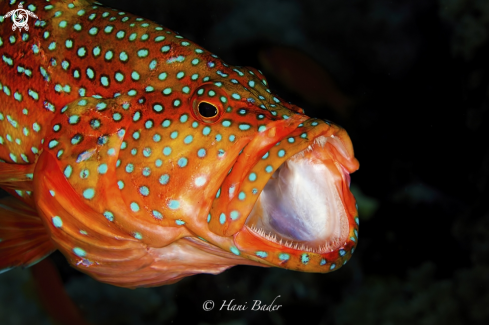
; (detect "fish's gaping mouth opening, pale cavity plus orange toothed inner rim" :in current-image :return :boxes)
[245,135,351,253]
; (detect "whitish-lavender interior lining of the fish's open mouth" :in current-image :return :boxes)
[246,135,348,252]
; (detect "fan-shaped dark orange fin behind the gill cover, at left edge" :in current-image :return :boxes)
[0,197,56,273]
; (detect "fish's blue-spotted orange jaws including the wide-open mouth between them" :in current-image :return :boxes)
[209,115,359,272]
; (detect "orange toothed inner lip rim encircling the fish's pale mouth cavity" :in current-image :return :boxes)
[236,124,359,254]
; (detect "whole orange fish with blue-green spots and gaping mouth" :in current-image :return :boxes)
[0,0,359,287]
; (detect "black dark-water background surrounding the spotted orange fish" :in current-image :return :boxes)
[0,0,489,325]
